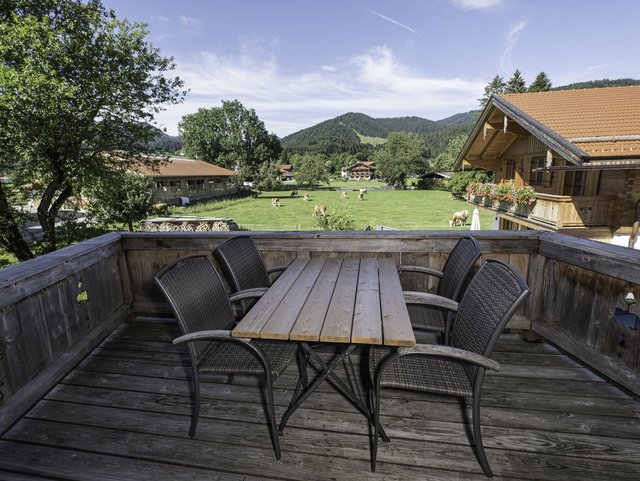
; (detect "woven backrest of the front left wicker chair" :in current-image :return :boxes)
[154,255,235,362]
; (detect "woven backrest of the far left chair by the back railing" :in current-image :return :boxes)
[213,236,271,292]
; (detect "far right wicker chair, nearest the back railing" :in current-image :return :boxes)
[398,236,480,345]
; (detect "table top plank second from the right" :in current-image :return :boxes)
[351,258,382,345]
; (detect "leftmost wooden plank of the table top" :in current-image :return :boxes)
[232,257,311,339]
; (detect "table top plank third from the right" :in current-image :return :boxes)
[320,259,360,343]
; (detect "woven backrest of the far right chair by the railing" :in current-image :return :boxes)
[437,236,481,301]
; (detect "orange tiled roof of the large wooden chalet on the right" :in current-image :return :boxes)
[502,85,640,157]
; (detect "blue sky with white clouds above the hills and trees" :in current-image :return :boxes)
[103,0,640,137]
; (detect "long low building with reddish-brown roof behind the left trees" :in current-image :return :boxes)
[136,157,236,205]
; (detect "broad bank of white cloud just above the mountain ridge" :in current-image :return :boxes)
[152,43,485,136]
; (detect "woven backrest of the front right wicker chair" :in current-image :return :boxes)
[451,259,529,386]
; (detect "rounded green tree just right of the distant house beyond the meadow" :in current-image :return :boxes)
[373,132,426,189]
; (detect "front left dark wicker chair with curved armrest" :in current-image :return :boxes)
[155,255,303,459]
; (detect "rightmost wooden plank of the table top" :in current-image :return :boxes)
[378,258,416,346]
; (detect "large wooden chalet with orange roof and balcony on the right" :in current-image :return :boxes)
[456,86,640,247]
